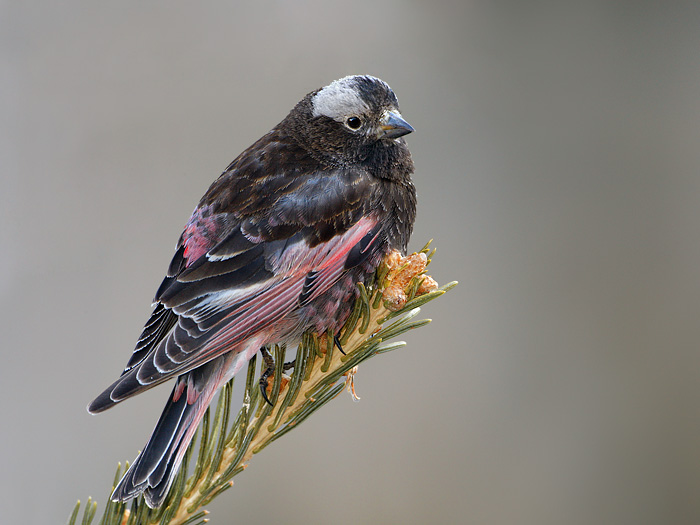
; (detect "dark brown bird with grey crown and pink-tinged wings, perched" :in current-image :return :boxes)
[88,75,417,508]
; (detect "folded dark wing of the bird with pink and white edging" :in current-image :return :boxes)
[89,136,381,412]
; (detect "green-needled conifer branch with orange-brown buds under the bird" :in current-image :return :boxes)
[68,242,457,525]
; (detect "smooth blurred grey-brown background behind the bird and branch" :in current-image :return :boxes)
[0,1,700,525]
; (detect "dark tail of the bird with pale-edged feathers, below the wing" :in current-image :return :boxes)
[112,356,226,508]
